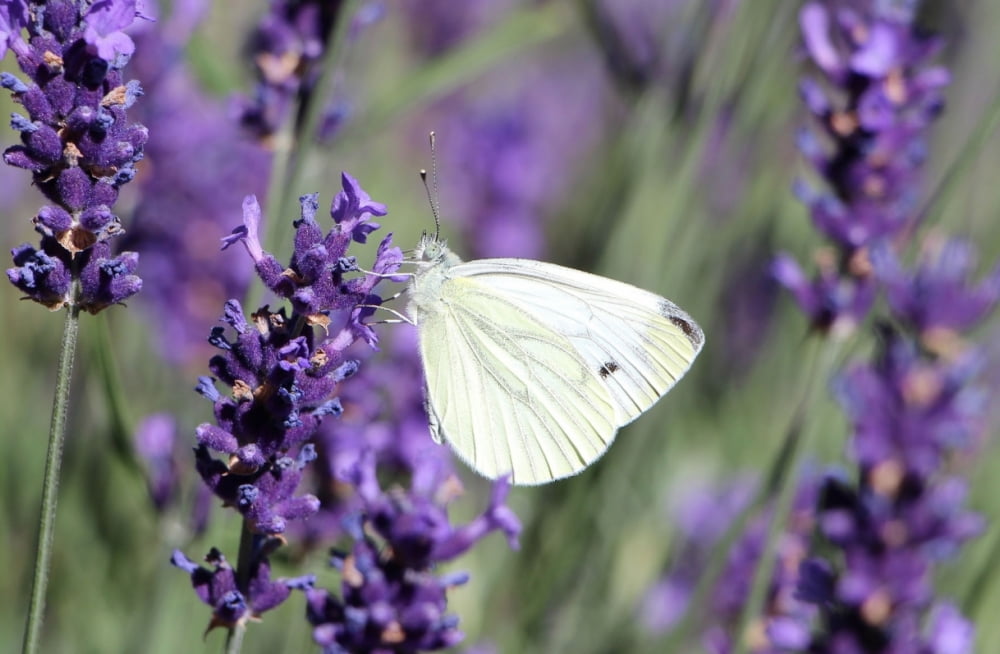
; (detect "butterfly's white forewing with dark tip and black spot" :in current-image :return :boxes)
[450,259,705,427]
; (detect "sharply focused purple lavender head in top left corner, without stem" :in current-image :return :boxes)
[0,0,148,313]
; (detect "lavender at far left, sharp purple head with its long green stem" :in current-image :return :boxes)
[0,0,148,652]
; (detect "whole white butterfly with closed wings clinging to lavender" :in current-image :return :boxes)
[408,235,705,484]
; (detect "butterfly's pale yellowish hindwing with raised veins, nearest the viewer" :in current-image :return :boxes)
[417,276,617,484]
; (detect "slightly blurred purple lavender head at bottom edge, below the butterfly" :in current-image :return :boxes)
[306,452,521,654]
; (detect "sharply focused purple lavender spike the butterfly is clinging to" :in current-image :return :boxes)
[175,174,406,626]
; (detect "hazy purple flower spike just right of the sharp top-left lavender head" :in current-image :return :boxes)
[124,2,271,364]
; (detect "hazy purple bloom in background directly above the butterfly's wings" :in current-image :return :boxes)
[426,51,610,258]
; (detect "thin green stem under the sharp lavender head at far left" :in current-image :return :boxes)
[21,302,80,654]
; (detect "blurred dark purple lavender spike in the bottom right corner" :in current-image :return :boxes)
[784,322,987,654]
